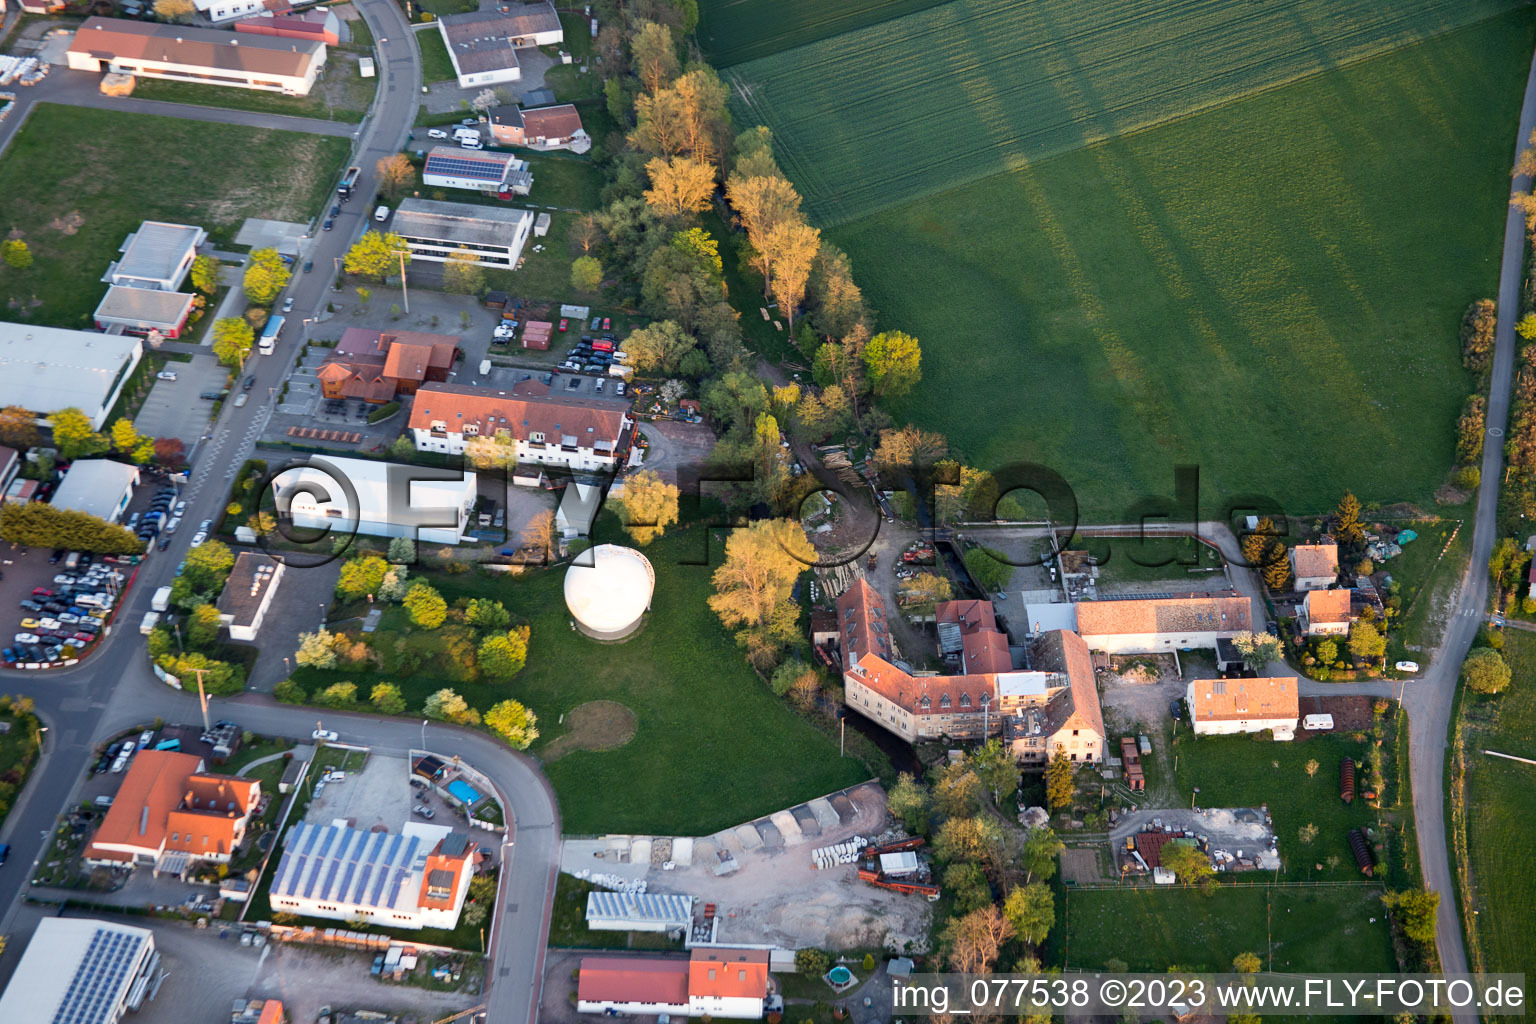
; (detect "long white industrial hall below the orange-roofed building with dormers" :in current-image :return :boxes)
[272,456,476,543]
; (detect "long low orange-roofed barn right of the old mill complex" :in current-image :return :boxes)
[1077,594,1253,654]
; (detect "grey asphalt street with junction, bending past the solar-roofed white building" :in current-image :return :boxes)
[0,8,561,1024]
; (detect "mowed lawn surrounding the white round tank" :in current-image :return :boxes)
[295,516,872,835]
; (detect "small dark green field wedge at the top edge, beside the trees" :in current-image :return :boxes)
[697,0,945,68]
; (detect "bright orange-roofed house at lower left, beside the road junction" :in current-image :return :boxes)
[84,751,261,875]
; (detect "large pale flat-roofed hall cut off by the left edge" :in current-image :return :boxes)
[0,322,144,430]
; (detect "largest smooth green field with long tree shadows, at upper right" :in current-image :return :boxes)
[829,16,1536,522]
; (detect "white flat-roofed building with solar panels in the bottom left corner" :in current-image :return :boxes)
[0,918,160,1024]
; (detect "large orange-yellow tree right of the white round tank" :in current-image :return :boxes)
[710,519,816,628]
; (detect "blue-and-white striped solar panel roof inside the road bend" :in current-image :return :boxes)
[272,824,425,909]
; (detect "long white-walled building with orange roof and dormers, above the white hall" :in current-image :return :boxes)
[409,378,634,471]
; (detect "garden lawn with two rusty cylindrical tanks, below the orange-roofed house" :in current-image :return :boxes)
[1175,721,1418,886]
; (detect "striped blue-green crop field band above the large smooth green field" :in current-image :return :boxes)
[725,0,1524,226]
